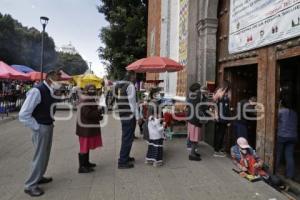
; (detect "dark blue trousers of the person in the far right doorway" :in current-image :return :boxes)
[276,137,296,178]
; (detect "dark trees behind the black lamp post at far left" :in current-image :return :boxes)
[0,15,57,70]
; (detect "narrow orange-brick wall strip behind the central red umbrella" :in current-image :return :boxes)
[146,0,162,80]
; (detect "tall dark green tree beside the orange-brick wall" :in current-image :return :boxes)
[98,0,147,79]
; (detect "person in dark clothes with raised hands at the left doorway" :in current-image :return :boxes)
[213,80,231,157]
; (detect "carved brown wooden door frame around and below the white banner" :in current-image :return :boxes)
[217,0,300,171]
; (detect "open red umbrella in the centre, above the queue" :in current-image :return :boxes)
[126,56,183,73]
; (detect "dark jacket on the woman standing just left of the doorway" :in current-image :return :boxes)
[187,91,202,127]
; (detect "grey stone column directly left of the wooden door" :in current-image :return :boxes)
[187,0,218,86]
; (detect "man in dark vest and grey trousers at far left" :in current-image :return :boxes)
[19,71,61,197]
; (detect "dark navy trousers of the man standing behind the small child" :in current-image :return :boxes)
[119,117,136,164]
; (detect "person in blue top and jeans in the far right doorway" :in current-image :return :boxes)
[276,98,298,179]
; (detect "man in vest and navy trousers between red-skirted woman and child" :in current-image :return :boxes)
[115,72,141,169]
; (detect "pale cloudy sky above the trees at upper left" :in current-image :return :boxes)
[0,0,108,77]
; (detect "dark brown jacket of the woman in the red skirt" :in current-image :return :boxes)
[76,99,103,137]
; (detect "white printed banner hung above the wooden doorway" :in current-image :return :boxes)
[228,0,300,53]
